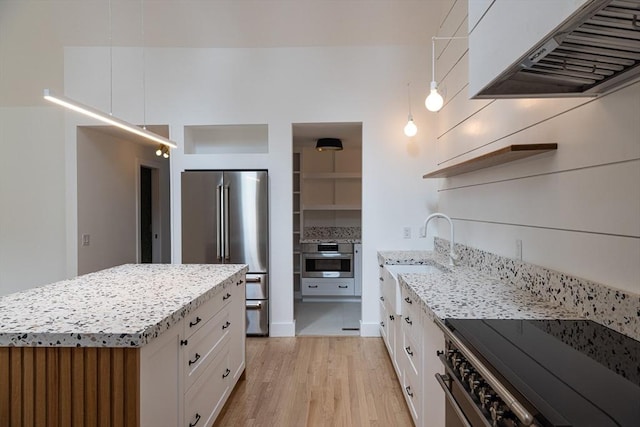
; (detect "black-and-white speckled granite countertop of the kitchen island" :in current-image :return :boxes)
[0,264,247,347]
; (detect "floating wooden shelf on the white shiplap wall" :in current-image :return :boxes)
[422,144,558,178]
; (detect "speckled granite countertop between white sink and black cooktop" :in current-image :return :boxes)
[378,251,581,320]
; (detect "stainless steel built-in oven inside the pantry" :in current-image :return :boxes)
[302,243,353,279]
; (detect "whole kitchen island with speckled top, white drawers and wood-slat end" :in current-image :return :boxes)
[0,264,247,426]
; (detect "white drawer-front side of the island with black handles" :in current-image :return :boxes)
[140,276,245,427]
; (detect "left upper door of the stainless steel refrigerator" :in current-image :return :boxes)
[181,171,223,264]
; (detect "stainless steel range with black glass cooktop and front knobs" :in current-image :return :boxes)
[436,319,640,427]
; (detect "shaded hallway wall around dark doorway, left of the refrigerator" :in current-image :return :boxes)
[77,127,171,274]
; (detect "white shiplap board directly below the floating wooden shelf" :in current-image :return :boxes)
[440,160,640,238]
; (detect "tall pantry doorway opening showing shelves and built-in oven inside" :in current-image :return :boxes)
[292,123,362,336]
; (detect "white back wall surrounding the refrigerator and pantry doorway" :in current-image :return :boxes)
[60,41,442,335]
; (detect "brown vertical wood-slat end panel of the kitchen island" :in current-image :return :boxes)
[0,347,140,427]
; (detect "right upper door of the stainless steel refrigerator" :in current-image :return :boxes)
[224,171,269,273]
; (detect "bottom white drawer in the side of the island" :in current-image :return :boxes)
[184,348,231,427]
